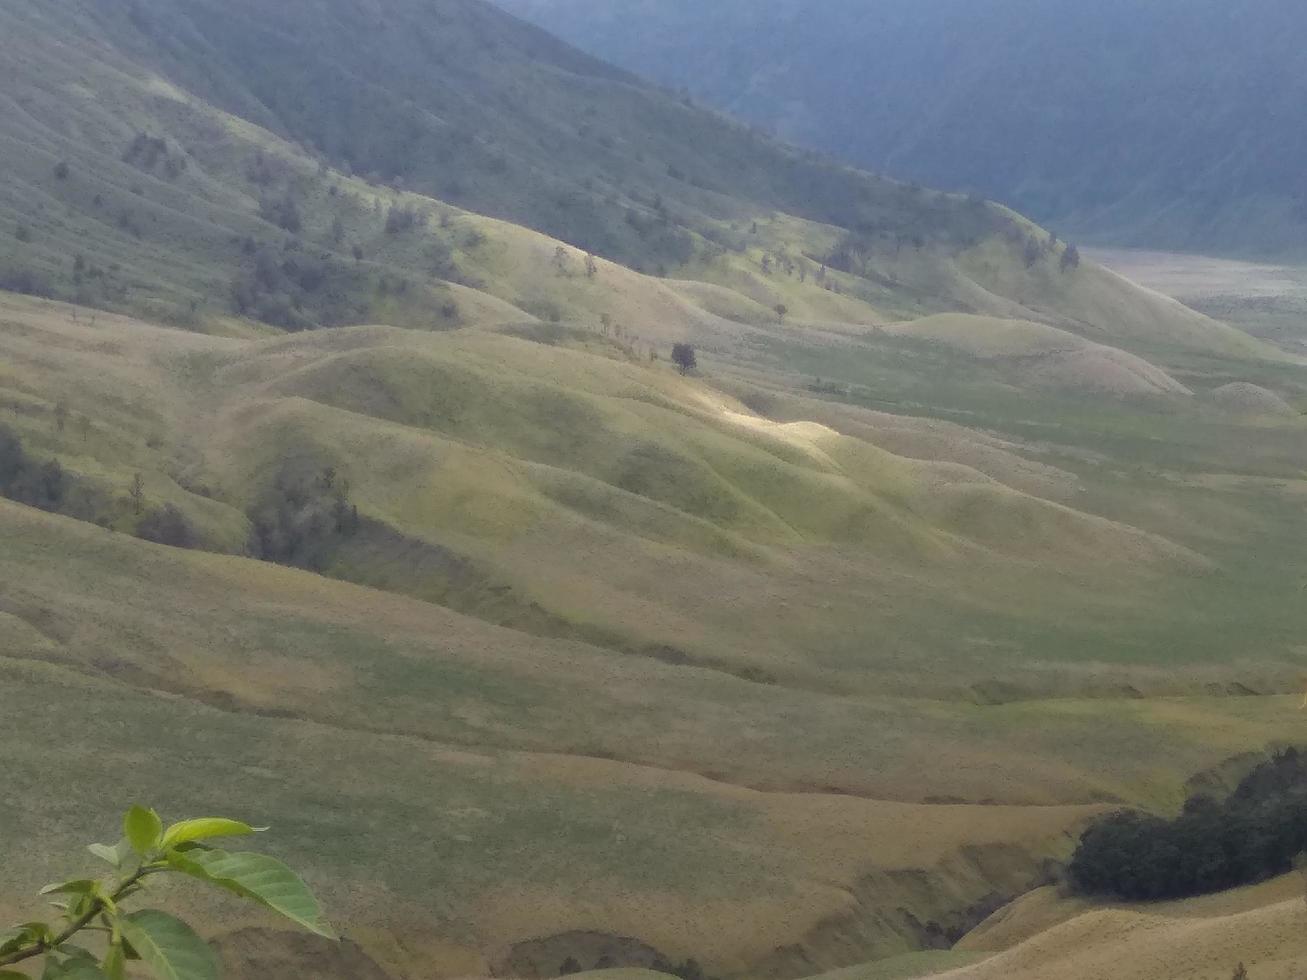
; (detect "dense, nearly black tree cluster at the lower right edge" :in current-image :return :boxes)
[1068,749,1307,900]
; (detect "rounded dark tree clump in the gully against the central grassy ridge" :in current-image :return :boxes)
[250,466,362,571]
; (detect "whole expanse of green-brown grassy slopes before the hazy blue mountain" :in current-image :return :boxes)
[0,0,1307,980]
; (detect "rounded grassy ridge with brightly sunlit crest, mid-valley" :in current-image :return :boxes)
[9,295,1280,698]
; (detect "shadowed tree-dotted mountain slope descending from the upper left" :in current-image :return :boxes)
[0,0,1270,368]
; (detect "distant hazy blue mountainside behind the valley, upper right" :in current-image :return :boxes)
[502,0,1307,253]
